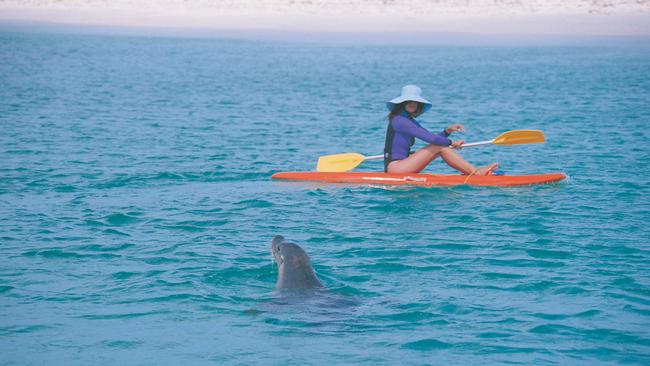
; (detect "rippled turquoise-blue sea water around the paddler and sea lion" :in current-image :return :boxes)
[0,28,650,365]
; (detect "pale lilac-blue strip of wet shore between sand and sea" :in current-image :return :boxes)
[5,19,650,48]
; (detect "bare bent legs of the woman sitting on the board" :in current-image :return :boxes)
[388,144,497,175]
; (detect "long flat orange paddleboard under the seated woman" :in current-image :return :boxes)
[271,172,566,187]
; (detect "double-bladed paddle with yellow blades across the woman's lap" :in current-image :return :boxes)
[316,130,546,172]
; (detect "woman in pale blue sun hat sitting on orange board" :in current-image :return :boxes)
[384,85,497,175]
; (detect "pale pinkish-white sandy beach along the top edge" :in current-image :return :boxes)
[0,0,650,36]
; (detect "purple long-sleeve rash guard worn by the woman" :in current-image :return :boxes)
[385,114,451,162]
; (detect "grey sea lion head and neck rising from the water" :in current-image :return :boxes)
[271,235,323,290]
